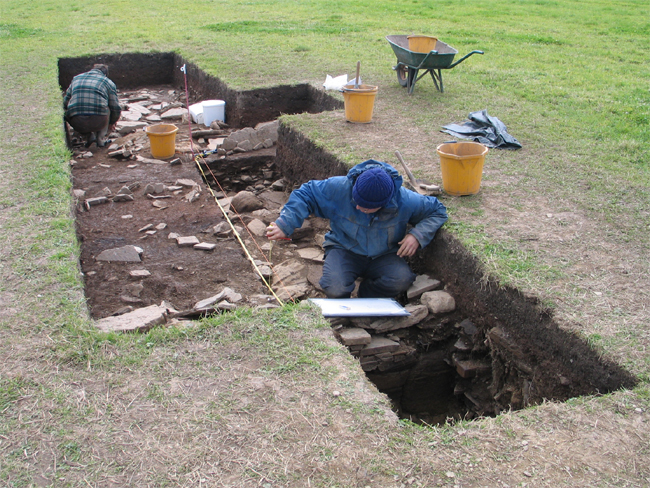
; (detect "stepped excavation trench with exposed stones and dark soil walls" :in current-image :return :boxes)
[59,53,636,424]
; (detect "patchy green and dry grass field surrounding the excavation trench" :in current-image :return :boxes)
[0,0,650,487]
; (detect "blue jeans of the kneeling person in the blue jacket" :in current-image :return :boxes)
[320,248,415,298]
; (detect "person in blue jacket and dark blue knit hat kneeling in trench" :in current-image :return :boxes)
[266,159,447,298]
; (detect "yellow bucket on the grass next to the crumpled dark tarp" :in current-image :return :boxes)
[437,142,488,196]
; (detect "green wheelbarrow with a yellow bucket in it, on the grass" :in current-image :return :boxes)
[386,36,483,95]
